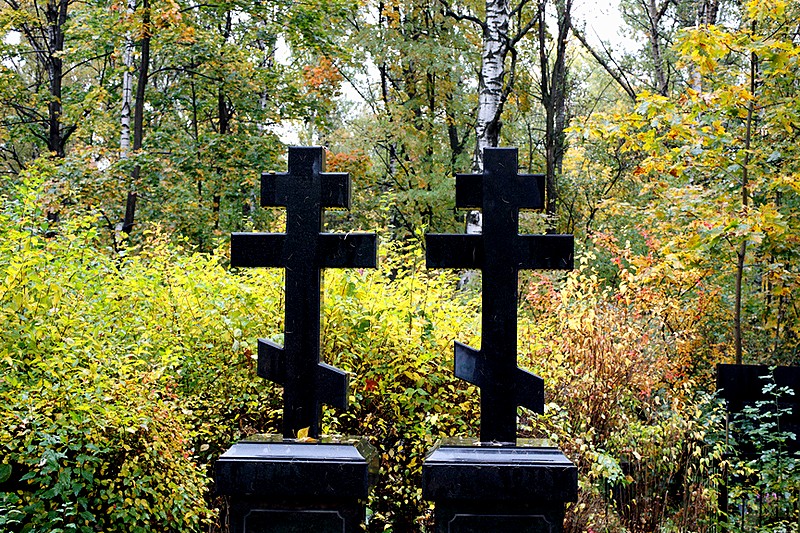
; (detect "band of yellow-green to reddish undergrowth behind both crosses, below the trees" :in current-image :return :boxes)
[0,177,788,532]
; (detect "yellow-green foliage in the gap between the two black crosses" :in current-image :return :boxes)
[323,243,479,531]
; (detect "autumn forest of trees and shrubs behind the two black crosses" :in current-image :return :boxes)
[0,0,800,532]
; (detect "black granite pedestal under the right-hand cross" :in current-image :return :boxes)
[422,439,578,533]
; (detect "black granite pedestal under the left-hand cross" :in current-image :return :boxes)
[214,435,378,533]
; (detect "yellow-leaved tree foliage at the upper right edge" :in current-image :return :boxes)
[566,1,800,363]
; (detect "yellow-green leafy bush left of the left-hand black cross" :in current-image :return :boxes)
[0,174,280,532]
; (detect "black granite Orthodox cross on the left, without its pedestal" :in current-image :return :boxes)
[231,146,377,438]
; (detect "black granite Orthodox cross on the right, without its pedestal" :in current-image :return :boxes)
[426,148,574,442]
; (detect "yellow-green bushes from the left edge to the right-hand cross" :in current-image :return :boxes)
[0,175,479,531]
